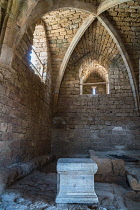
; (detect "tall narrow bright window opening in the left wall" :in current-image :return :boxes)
[30,25,47,79]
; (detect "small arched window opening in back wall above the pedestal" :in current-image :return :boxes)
[79,58,109,95]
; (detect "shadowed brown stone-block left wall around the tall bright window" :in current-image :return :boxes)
[0,23,51,166]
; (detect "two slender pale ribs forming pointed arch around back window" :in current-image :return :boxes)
[54,10,139,114]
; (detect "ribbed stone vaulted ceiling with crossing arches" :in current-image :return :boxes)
[0,0,140,114]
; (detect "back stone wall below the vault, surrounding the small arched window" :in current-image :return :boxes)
[52,56,140,156]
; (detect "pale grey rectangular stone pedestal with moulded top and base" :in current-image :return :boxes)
[56,158,98,204]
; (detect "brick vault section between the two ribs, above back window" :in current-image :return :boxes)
[70,19,119,68]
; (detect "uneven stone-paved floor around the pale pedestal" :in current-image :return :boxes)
[0,162,140,210]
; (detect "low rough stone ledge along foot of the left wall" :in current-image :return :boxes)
[0,154,55,194]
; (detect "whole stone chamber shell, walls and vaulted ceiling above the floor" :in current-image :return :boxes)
[0,0,140,166]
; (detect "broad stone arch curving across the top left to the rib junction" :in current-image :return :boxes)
[0,0,132,64]
